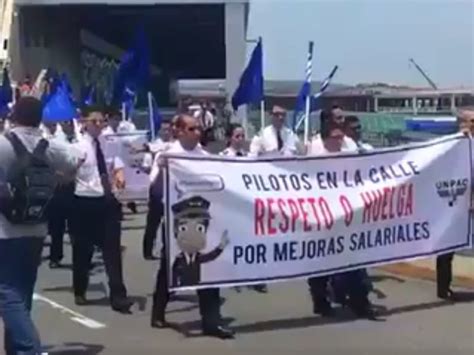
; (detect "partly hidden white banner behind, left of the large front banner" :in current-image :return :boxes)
[104,131,150,201]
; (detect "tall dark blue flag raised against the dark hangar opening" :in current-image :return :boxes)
[112,28,150,103]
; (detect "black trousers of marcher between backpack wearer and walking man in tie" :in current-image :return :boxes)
[48,184,74,262]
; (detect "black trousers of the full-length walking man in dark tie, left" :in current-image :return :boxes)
[71,196,127,301]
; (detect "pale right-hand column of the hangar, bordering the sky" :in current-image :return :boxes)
[225,3,248,123]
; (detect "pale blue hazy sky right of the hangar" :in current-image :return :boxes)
[248,0,474,88]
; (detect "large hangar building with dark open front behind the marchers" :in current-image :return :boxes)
[0,0,249,105]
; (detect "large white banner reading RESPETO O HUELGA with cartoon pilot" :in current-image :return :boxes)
[165,136,471,290]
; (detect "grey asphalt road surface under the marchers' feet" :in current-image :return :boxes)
[0,207,474,355]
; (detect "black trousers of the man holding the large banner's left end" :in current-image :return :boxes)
[151,232,221,328]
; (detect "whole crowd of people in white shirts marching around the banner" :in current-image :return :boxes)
[0,96,474,354]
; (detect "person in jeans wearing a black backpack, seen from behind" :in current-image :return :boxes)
[0,97,81,354]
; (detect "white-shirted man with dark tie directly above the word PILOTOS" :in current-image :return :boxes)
[249,105,302,156]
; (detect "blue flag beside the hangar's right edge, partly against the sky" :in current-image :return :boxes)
[232,40,264,110]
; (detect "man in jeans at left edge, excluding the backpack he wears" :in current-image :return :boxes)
[0,97,80,354]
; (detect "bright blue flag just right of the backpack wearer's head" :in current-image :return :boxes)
[43,86,77,122]
